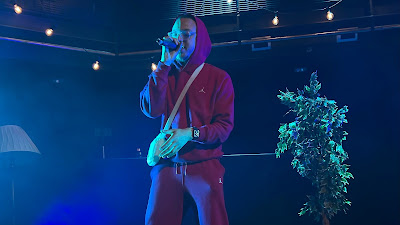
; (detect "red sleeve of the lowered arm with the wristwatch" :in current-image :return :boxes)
[197,75,235,144]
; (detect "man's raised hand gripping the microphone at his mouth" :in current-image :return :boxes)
[156,36,183,66]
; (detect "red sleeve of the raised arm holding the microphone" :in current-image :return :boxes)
[140,62,171,118]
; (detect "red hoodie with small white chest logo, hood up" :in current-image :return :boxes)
[140,17,234,162]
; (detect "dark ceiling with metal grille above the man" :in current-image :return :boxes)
[0,0,400,56]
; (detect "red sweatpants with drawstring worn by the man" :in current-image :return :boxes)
[146,159,229,225]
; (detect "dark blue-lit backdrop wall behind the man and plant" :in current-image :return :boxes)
[0,0,400,225]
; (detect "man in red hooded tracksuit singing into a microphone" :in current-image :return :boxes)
[140,15,234,225]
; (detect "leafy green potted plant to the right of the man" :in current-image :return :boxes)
[275,72,354,225]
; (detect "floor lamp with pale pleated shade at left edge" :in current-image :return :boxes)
[0,125,40,224]
